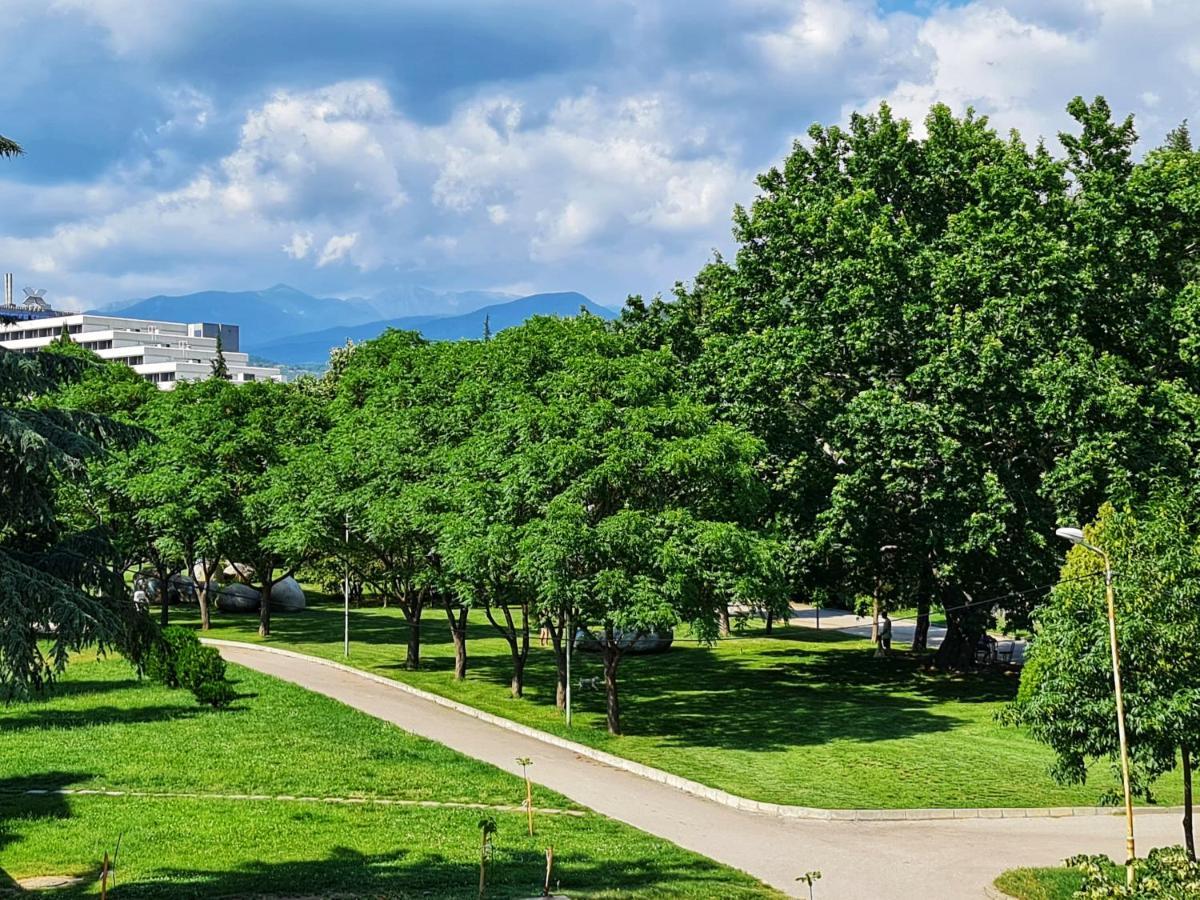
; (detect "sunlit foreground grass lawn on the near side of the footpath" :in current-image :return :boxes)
[0,659,778,900]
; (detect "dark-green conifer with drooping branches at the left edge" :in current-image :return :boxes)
[0,348,151,697]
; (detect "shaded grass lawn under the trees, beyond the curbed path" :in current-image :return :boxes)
[173,594,1182,809]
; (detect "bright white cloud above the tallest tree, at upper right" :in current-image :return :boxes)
[842,0,1200,143]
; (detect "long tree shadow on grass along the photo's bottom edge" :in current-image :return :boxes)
[87,847,751,900]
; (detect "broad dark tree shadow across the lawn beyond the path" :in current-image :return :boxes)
[446,626,1016,750]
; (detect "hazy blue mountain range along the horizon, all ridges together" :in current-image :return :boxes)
[92,284,617,366]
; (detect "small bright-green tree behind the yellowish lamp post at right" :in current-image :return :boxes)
[1006,501,1200,858]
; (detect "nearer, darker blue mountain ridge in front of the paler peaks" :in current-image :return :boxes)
[254,296,617,366]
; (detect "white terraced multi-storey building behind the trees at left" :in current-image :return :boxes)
[0,286,283,390]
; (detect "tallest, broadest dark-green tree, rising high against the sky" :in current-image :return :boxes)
[622,98,1200,666]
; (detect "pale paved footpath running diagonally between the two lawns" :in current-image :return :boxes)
[220,644,1182,900]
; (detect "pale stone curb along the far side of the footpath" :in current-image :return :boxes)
[200,637,1183,822]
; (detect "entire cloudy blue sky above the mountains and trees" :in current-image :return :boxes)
[0,0,1200,308]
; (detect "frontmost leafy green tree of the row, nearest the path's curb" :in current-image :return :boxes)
[501,317,764,733]
